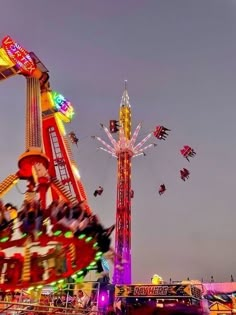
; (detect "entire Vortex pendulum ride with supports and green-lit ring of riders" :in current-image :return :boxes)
[0,36,109,291]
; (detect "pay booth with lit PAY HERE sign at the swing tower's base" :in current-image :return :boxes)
[115,284,202,315]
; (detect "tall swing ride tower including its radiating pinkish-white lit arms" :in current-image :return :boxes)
[96,81,168,284]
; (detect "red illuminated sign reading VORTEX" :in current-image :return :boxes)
[2,36,36,75]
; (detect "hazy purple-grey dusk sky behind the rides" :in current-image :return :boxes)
[0,0,236,283]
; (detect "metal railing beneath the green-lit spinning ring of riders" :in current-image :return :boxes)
[0,281,104,315]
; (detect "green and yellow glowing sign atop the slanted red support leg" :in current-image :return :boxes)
[52,91,74,121]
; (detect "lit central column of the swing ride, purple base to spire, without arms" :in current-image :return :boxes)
[114,81,133,284]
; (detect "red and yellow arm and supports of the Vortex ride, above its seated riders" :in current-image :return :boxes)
[0,36,90,211]
